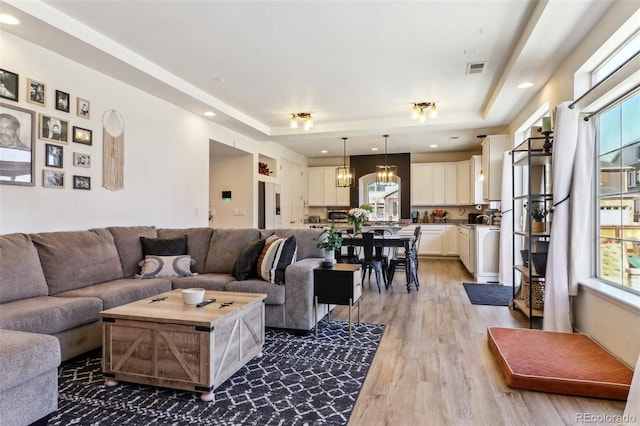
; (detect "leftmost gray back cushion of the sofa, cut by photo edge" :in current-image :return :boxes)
[0,234,49,303]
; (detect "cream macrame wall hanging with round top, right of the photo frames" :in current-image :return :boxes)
[102,109,124,191]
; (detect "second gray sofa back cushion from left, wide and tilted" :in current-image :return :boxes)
[31,229,123,295]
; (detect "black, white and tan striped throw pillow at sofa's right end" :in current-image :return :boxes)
[258,235,297,284]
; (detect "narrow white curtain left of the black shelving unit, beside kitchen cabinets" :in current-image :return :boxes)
[498,151,513,286]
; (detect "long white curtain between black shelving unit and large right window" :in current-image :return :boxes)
[542,102,586,332]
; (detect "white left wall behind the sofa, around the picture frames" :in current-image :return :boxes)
[0,31,306,234]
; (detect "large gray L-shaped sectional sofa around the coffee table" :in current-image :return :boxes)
[0,226,327,424]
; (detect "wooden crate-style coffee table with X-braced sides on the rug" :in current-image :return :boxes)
[100,289,266,401]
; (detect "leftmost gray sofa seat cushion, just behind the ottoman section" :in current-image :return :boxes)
[0,296,103,334]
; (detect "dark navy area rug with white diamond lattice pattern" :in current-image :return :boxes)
[49,321,385,426]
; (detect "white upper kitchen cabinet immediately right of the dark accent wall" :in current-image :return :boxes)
[411,163,458,206]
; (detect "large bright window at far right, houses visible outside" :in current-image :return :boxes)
[597,91,640,293]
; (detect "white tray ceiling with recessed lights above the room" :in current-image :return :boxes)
[0,0,611,157]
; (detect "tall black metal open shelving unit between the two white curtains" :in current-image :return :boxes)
[511,136,553,328]
